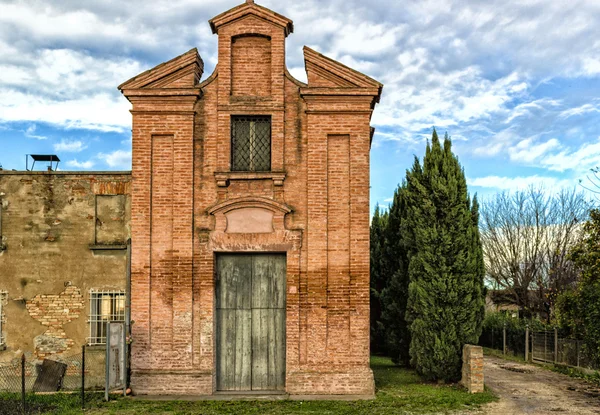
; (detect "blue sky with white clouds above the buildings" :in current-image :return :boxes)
[0,0,600,210]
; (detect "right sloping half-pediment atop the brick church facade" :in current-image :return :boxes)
[304,46,383,89]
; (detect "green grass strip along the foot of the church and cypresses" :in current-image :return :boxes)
[0,357,496,415]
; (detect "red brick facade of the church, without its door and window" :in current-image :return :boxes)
[123,0,377,395]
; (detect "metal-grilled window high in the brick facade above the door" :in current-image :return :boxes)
[231,116,271,171]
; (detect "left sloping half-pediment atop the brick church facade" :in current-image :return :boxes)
[119,48,204,91]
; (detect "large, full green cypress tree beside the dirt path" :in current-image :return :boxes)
[406,130,484,381]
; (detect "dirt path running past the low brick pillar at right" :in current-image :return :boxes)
[484,357,600,415]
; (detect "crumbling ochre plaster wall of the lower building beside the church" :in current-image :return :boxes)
[0,171,131,362]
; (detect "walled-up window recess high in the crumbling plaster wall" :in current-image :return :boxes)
[96,195,127,245]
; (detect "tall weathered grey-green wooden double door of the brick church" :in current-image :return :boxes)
[216,254,286,391]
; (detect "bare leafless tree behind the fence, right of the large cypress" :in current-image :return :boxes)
[480,187,590,316]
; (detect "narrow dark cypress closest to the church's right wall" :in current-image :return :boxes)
[370,205,388,354]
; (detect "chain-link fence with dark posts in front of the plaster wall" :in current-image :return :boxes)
[0,347,106,413]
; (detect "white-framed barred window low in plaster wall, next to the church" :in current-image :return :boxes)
[88,289,125,345]
